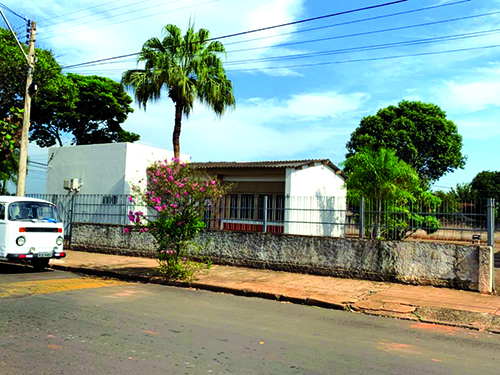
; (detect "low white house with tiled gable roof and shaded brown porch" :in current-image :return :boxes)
[191,159,347,237]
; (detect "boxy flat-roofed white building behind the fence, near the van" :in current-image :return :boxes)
[45,143,191,224]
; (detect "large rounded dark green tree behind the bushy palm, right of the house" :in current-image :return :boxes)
[346,100,466,186]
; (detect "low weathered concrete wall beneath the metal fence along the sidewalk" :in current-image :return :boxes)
[72,223,493,292]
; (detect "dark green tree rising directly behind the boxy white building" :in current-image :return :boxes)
[30,73,140,147]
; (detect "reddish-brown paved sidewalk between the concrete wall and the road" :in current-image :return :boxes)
[51,251,500,333]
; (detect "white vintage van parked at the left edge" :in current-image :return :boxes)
[0,196,66,269]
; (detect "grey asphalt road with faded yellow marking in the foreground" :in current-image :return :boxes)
[0,264,500,375]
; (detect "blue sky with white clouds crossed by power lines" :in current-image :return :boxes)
[0,0,500,193]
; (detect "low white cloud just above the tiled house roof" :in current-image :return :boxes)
[126,92,368,160]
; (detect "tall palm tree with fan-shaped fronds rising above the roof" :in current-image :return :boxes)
[122,24,235,158]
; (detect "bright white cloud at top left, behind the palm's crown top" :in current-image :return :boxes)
[22,0,304,79]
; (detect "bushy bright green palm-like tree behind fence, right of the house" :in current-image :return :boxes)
[343,148,439,239]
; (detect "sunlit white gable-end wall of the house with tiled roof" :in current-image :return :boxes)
[285,163,346,237]
